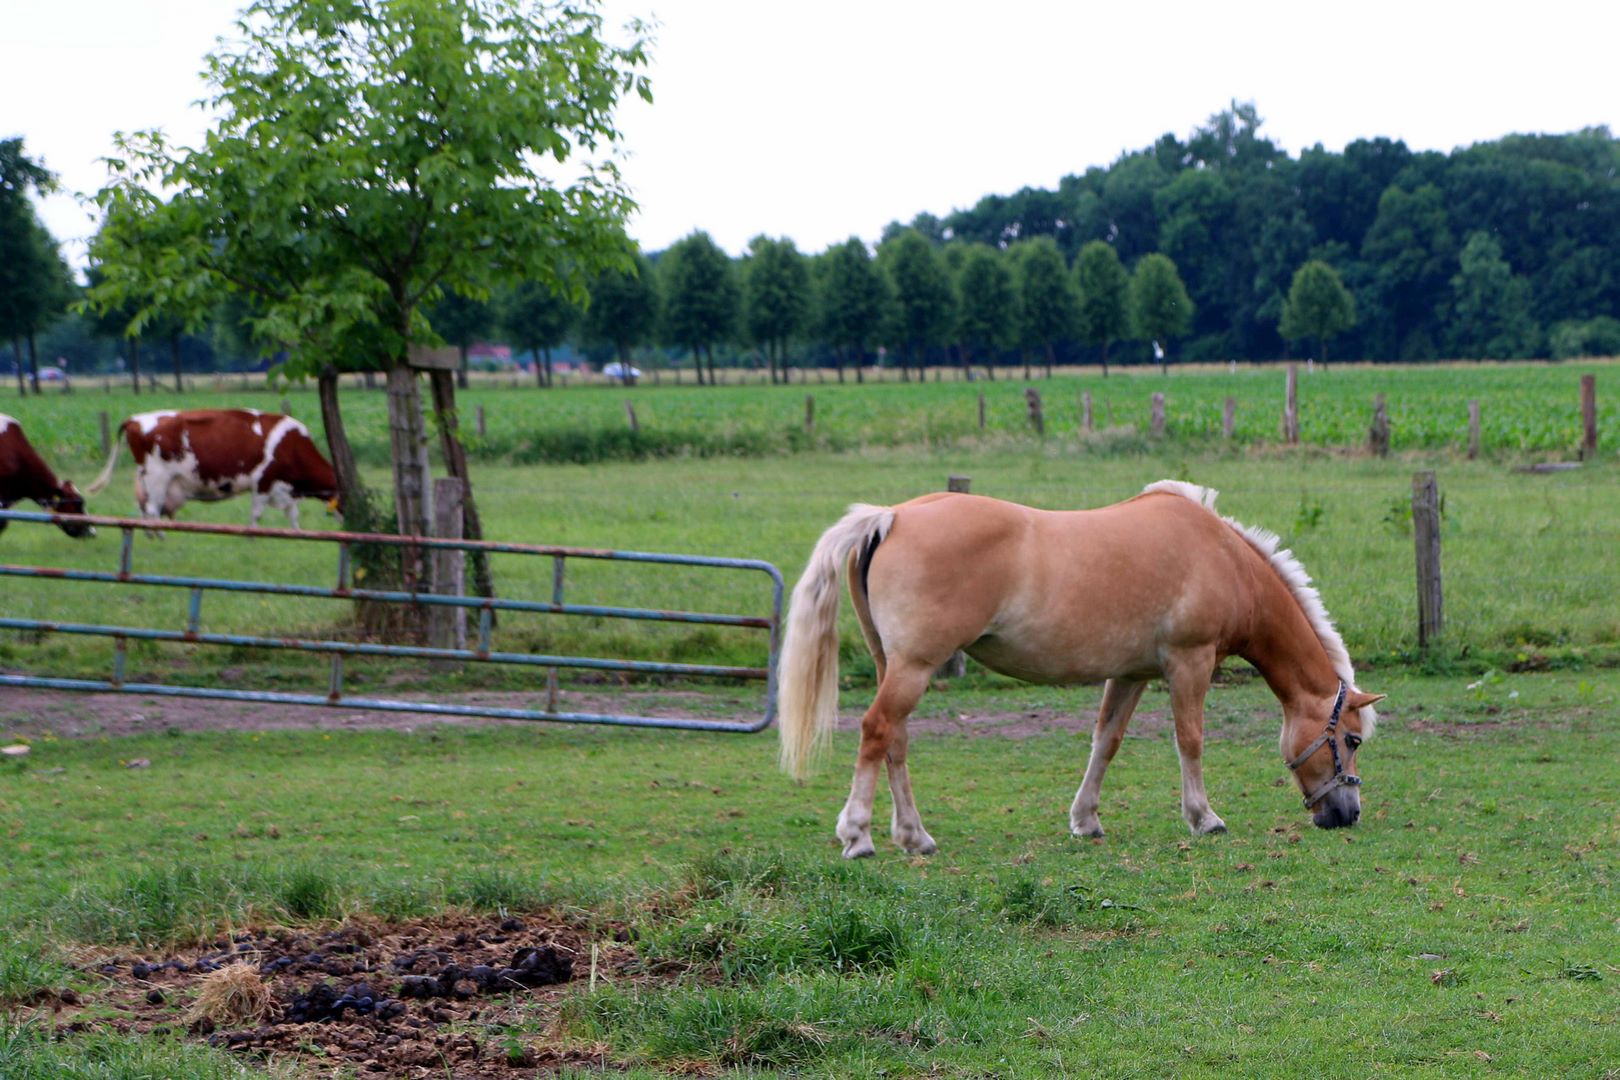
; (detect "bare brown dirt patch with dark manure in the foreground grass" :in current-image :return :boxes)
[34,915,648,1080]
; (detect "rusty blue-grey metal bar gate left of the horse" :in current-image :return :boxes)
[0,510,782,732]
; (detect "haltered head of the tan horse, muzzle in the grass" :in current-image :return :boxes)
[1281,683,1383,829]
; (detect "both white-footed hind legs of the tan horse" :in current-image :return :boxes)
[838,657,933,858]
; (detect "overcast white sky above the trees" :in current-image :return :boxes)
[0,0,1620,264]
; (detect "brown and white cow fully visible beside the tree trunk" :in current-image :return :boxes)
[86,408,337,528]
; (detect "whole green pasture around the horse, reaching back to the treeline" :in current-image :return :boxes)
[0,364,1620,1077]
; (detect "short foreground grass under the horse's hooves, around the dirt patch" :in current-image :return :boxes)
[0,670,1620,1077]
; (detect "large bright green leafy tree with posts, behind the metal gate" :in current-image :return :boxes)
[85,0,650,570]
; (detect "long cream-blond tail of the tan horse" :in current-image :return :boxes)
[776,502,894,779]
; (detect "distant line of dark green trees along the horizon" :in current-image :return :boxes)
[0,105,1620,382]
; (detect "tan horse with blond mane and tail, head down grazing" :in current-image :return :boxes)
[779,481,1383,858]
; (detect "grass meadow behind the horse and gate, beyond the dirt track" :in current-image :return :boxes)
[0,444,1620,693]
